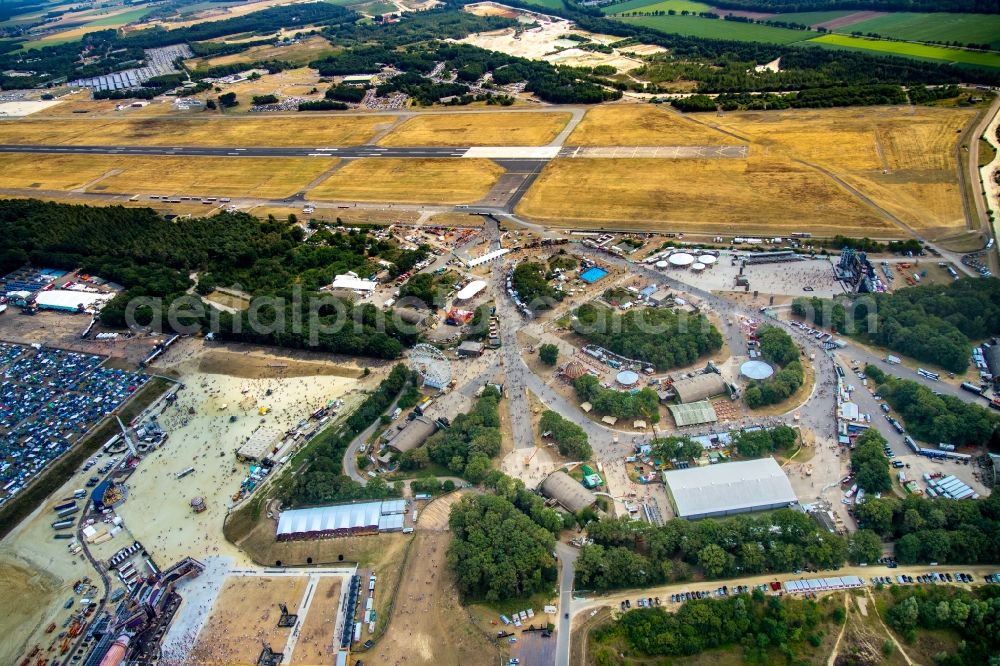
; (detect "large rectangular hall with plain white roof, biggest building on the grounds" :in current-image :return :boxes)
[663,458,798,520]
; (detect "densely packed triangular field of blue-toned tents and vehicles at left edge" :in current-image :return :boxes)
[0,343,148,503]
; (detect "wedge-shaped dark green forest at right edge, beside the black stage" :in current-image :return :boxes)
[792,278,1000,373]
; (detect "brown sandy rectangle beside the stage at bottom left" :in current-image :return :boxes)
[190,575,309,666]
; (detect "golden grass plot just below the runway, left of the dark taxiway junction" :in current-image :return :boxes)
[307,158,504,204]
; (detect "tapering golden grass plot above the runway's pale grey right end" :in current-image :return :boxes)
[566,104,743,146]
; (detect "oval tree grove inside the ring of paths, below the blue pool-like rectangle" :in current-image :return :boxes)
[575,303,722,372]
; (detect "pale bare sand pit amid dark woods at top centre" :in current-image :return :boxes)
[458,3,665,72]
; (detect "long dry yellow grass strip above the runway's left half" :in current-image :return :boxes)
[0,116,395,147]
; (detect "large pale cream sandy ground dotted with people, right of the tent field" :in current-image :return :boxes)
[118,344,364,566]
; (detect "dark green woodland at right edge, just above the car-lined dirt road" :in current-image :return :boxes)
[855,493,1000,564]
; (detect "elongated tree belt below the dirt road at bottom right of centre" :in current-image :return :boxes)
[594,592,825,663]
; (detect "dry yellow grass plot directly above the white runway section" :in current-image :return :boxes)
[379,111,571,146]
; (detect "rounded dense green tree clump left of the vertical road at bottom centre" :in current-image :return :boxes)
[448,495,556,601]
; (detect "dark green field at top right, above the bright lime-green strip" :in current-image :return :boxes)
[837,12,1000,49]
